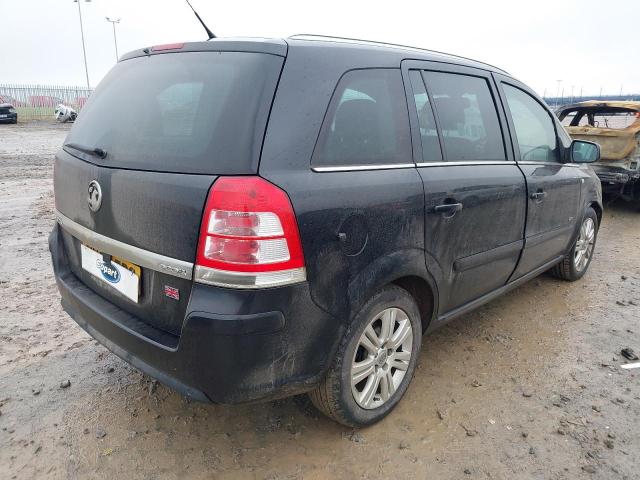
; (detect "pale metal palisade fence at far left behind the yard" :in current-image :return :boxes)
[0,83,92,122]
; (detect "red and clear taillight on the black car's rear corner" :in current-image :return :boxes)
[195,177,306,288]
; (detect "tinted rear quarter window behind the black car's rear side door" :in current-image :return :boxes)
[311,69,413,166]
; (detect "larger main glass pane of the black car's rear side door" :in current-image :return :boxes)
[425,72,506,162]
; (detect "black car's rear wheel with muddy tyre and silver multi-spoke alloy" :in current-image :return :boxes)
[309,286,422,427]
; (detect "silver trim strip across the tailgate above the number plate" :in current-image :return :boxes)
[55,210,193,280]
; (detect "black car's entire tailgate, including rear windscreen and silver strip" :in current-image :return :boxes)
[54,42,283,335]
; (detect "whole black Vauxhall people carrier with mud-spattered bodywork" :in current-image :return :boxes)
[49,37,602,425]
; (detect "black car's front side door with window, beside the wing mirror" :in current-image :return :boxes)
[496,75,582,279]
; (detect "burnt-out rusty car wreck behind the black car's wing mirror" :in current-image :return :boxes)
[557,100,640,200]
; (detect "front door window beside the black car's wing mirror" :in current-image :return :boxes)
[502,83,558,162]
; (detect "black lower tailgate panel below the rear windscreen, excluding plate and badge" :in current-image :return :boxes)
[54,156,216,335]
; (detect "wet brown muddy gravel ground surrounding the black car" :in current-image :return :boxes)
[0,124,640,479]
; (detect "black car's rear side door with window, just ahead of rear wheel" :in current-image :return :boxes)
[403,61,526,314]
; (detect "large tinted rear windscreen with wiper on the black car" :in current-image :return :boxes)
[65,52,283,174]
